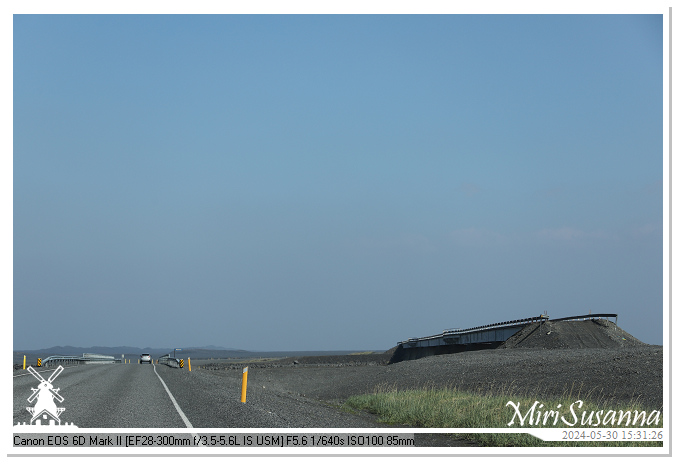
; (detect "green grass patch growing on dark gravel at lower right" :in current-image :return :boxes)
[345,388,663,447]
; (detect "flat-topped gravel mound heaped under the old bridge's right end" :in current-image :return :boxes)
[498,319,648,350]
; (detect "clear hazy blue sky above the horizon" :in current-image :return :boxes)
[13,15,663,350]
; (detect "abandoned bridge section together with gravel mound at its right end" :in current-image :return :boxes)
[389,314,624,364]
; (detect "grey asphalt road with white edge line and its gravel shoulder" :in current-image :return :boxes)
[13,364,383,428]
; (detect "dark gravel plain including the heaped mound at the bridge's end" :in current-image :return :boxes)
[194,319,663,410]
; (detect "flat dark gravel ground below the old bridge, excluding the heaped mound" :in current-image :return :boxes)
[194,345,663,409]
